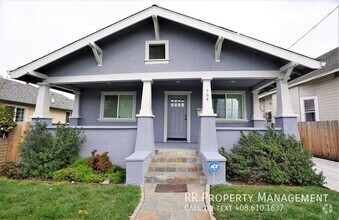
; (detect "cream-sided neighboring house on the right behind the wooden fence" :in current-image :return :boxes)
[260,47,339,122]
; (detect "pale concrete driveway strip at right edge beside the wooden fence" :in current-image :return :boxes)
[312,157,339,192]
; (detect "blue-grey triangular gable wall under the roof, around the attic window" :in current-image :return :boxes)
[39,18,281,76]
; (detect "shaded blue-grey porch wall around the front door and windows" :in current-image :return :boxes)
[79,80,253,143]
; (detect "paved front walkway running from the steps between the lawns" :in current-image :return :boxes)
[135,184,210,220]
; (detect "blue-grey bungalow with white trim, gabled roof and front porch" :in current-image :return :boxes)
[10,5,323,184]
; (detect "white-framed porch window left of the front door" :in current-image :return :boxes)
[100,92,136,120]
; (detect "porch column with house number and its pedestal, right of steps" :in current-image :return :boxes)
[199,78,226,185]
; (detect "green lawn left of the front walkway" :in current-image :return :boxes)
[0,178,140,219]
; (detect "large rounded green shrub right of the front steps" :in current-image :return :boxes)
[220,128,324,186]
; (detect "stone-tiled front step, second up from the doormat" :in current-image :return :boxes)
[148,163,202,173]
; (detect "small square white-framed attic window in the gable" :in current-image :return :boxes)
[145,40,169,64]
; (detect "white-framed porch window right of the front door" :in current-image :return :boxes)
[212,92,245,120]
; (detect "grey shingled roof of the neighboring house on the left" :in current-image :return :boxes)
[0,77,73,110]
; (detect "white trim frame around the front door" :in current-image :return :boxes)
[164,91,192,143]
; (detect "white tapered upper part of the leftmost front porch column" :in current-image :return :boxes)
[32,82,52,125]
